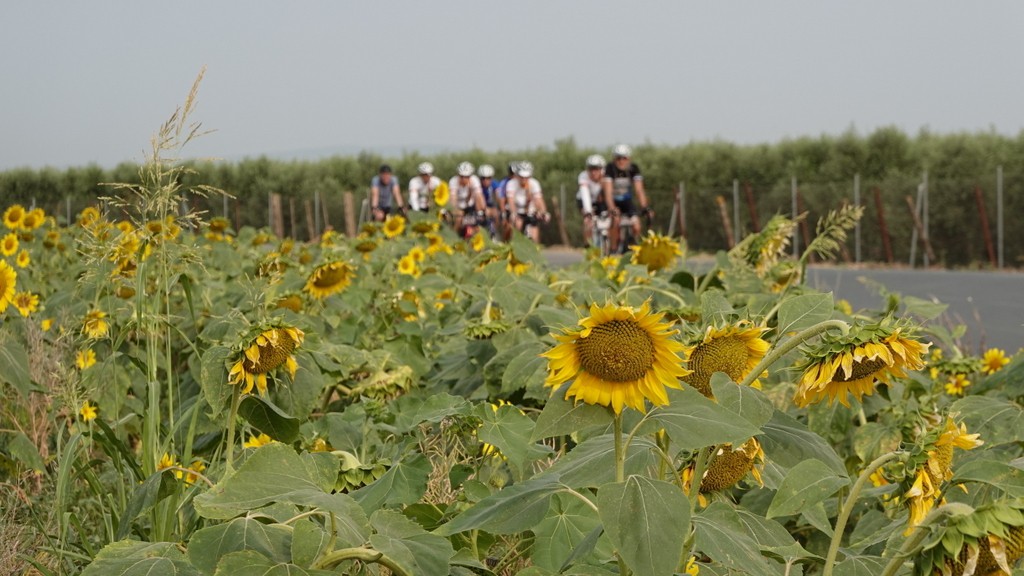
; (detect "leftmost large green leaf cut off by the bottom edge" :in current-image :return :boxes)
[82,540,200,576]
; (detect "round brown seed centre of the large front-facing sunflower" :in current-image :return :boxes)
[577,320,654,382]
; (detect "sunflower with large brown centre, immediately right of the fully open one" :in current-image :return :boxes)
[683,322,768,398]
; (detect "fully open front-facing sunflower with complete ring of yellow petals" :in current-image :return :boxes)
[541,302,690,414]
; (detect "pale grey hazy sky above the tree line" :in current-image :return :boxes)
[0,0,1024,169]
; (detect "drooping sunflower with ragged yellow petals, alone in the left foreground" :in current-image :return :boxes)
[227,327,305,396]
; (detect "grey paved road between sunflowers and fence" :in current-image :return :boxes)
[546,249,1024,354]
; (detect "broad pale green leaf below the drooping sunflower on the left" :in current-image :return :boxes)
[195,443,321,519]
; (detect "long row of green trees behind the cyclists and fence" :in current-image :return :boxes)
[0,127,1024,266]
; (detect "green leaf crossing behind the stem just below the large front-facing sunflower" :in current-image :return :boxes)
[542,432,655,489]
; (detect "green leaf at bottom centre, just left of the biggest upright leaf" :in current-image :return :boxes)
[532,494,612,571]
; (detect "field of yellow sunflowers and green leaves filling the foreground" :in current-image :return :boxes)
[6,89,1024,576]
